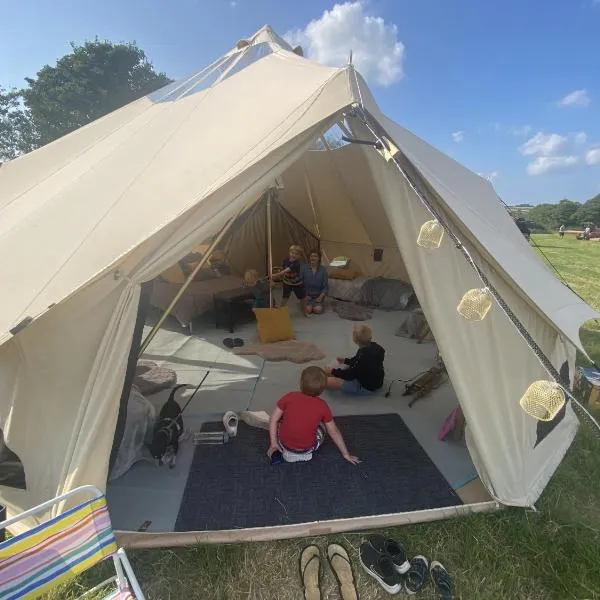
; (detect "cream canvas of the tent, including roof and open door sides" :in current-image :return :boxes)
[0,27,599,528]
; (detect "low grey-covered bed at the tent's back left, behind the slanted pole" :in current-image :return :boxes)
[150,275,242,327]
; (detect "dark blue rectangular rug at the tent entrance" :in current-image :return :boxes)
[175,414,462,531]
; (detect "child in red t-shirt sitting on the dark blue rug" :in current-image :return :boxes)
[267,367,360,465]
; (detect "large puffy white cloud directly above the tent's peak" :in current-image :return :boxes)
[284,0,404,86]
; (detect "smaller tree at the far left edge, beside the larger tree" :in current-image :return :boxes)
[0,87,37,163]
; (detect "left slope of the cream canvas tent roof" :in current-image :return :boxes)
[0,28,354,343]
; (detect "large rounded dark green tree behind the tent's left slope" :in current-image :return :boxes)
[23,39,171,145]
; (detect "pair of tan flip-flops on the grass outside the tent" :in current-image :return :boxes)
[300,544,358,600]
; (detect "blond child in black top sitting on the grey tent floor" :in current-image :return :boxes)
[325,325,385,394]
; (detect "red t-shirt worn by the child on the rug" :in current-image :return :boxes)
[277,392,333,450]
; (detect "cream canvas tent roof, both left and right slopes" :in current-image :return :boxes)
[0,26,600,348]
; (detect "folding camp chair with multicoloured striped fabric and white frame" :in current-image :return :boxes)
[0,485,144,600]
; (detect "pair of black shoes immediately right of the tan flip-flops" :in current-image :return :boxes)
[359,535,411,595]
